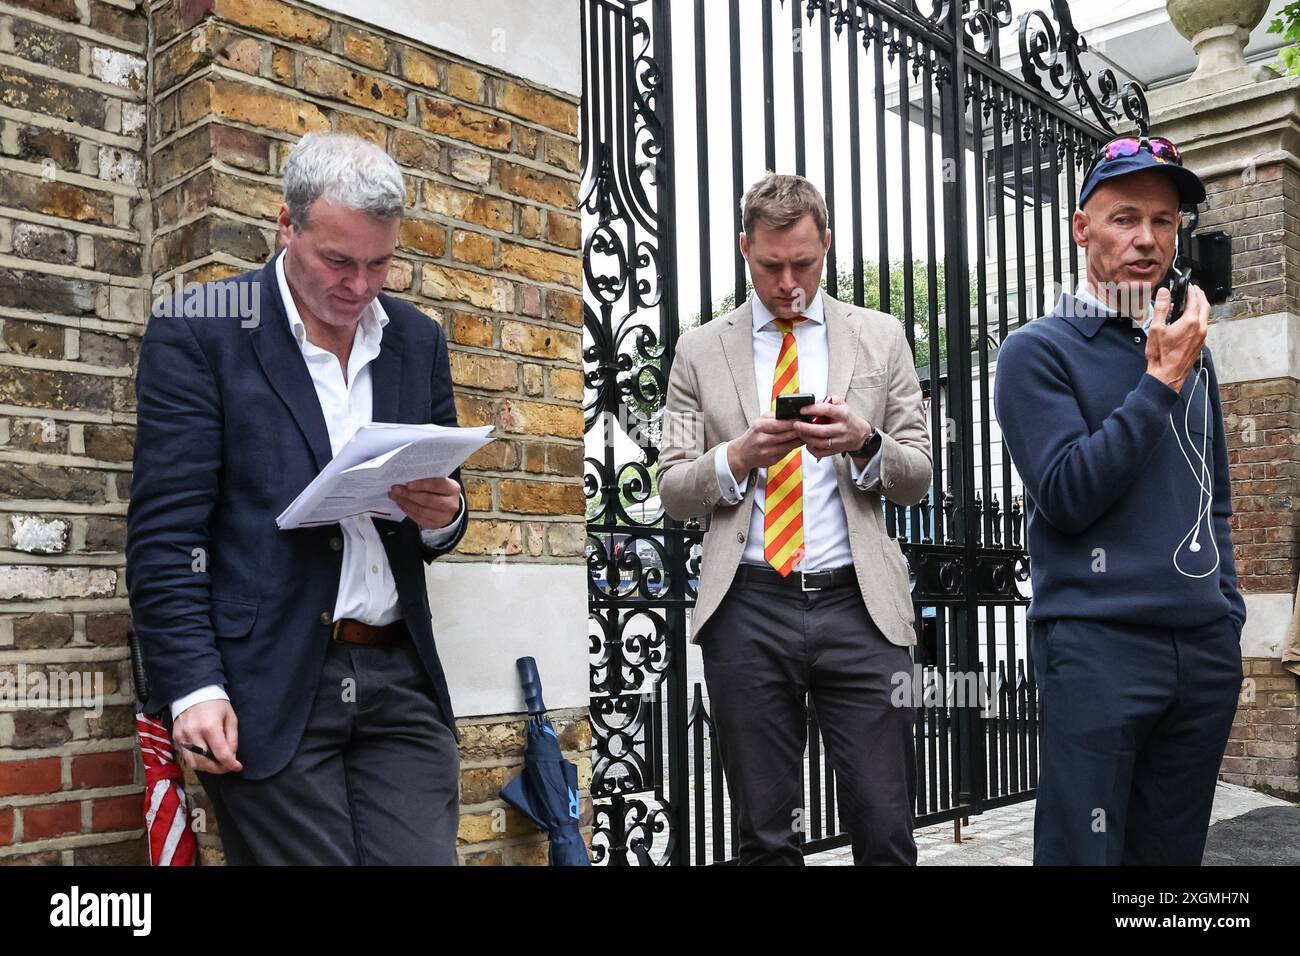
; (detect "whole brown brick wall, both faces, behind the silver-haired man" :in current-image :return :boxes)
[0,0,590,864]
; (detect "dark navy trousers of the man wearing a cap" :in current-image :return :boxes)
[1030,617,1242,866]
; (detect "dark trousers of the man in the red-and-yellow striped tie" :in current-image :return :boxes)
[699,567,917,866]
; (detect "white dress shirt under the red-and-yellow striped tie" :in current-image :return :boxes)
[715,291,884,571]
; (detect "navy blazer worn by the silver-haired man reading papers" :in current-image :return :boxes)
[126,258,468,779]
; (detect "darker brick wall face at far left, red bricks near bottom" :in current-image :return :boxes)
[0,0,150,864]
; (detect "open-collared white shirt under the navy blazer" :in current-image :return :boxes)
[172,254,465,721]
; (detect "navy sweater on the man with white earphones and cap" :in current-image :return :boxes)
[993,295,1245,633]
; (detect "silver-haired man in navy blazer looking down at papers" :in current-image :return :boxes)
[126,128,468,864]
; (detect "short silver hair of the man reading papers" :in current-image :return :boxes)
[285,133,406,229]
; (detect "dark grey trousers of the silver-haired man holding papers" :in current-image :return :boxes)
[199,641,460,866]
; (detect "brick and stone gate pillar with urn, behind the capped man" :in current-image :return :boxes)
[1149,0,1300,800]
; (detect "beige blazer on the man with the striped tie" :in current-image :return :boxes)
[659,293,931,646]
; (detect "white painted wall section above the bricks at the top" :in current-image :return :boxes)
[313,0,582,96]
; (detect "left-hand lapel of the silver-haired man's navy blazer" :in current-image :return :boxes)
[250,252,334,471]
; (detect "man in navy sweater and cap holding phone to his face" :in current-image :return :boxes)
[995,137,1245,865]
